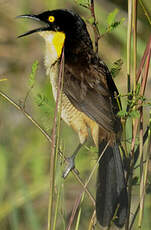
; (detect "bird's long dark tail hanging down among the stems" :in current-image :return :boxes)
[96,141,128,227]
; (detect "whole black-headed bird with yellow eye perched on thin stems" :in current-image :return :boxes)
[18,9,128,228]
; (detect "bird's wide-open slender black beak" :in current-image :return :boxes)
[16,14,49,38]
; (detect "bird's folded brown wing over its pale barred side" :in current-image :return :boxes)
[63,67,116,132]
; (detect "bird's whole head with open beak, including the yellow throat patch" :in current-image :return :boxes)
[17,9,92,61]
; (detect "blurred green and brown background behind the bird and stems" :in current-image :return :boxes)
[0,0,151,230]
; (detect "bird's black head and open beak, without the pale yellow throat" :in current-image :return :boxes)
[18,9,92,61]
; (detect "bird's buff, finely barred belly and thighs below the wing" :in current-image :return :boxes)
[49,63,110,146]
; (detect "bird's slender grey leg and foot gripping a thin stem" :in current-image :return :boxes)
[62,143,82,178]
